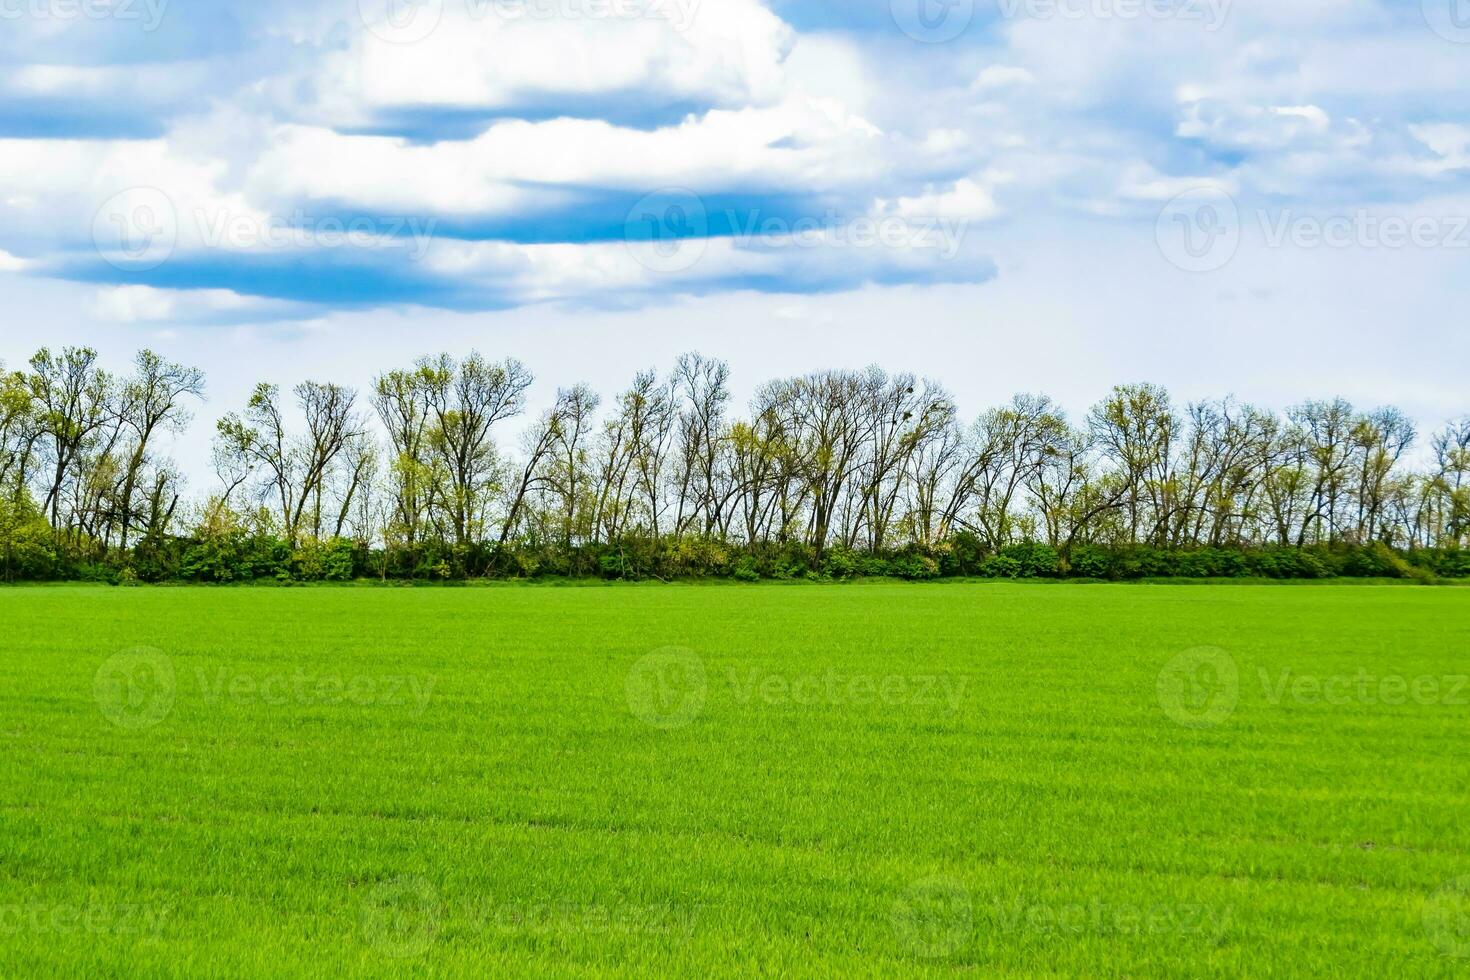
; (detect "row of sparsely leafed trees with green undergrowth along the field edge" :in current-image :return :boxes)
[0,347,1470,582]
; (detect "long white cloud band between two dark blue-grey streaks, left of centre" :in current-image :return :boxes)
[248,98,881,215]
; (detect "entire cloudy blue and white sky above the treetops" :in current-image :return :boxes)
[0,0,1470,489]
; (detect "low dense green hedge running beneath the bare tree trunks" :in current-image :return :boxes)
[14,533,1470,583]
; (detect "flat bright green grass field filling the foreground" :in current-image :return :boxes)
[0,583,1470,977]
